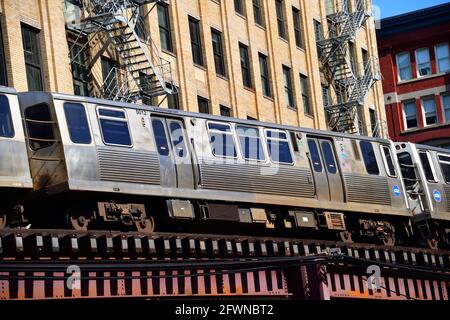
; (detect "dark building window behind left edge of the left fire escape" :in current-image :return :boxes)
[69,43,89,96]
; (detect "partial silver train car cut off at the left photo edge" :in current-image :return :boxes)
[0,87,32,228]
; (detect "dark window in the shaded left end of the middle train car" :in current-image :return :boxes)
[25,104,56,151]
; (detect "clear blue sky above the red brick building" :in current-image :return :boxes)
[373,0,449,18]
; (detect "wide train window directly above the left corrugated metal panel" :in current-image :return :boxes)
[98,108,132,147]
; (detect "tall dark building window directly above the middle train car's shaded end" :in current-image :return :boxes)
[22,25,43,91]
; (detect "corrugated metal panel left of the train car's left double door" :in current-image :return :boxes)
[97,148,161,185]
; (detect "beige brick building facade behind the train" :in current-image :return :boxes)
[0,0,386,135]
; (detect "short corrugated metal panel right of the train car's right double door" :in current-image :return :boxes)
[344,174,392,206]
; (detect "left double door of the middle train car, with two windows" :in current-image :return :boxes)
[152,117,194,188]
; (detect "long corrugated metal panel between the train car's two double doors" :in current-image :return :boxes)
[200,159,315,198]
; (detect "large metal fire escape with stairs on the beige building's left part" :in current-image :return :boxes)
[67,0,175,102]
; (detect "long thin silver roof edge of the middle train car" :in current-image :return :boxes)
[25,92,389,143]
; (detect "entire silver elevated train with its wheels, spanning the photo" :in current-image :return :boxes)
[0,88,450,247]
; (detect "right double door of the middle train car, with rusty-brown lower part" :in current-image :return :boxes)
[308,138,344,202]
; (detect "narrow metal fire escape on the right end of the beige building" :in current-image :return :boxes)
[317,0,381,133]
